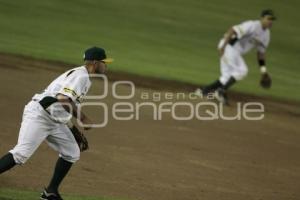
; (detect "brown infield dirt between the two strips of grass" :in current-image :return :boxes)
[0,54,300,200]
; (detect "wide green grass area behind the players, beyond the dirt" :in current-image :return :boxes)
[0,0,300,101]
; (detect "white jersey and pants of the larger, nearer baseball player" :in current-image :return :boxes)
[9,66,91,164]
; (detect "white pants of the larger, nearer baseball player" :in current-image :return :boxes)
[9,101,80,164]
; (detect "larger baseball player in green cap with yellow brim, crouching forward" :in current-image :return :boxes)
[0,47,112,200]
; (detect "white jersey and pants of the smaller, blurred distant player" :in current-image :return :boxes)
[218,20,270,85]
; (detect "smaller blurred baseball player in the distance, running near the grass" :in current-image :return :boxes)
[195,9,276,104]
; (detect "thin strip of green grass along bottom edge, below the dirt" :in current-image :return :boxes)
[0,189,124,200]
